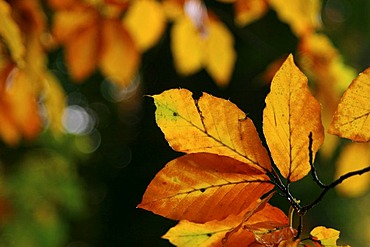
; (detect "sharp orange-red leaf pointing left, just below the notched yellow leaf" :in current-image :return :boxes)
[138,153,273,223]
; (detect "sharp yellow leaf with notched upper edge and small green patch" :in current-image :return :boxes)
[153,89,271,171]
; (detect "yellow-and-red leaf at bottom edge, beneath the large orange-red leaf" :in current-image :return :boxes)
[162,194,288,247]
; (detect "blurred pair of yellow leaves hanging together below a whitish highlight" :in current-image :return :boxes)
[171,0,236,86]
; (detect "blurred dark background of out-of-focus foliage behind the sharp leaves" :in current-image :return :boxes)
[0,0,370,247]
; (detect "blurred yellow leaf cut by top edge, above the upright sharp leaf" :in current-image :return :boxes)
[268,0,321,37]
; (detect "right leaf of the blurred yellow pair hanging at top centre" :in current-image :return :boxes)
[204,20,236,87]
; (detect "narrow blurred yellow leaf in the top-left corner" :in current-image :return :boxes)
[0,0,26,67]
